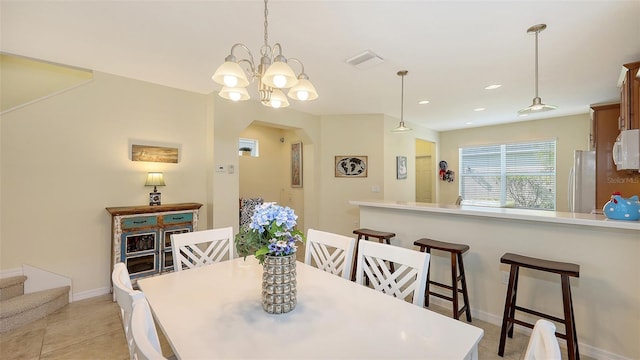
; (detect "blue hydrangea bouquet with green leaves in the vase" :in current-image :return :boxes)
[235,202,304,264]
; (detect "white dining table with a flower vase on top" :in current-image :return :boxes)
[138,257,483,360]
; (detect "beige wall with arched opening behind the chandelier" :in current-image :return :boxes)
[209,96,320,232]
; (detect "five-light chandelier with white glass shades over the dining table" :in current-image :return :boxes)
[211,0,318,108]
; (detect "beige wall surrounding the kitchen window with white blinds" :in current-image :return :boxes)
[436,113,590,211]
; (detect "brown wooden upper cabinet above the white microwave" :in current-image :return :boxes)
[618,61,640,130]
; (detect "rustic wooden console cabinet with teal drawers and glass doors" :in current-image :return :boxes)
[107,203,202,282]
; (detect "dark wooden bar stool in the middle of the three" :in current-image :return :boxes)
[413,238,471,322]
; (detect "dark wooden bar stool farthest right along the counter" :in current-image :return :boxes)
[498,253,580,360]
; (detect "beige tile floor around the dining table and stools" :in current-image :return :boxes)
[0,295,589,360]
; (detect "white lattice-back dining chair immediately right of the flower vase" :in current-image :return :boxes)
[304,229,356,279]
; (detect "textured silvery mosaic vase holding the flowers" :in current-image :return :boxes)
[262,253,297,314]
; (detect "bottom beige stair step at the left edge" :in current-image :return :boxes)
[0,286,71,333]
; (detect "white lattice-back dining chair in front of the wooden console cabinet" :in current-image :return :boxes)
[171,227,234,271]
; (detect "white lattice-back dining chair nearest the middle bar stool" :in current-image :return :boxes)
[356,241,429,307]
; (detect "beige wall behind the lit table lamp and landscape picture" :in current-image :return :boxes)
[0,73,212,294]
